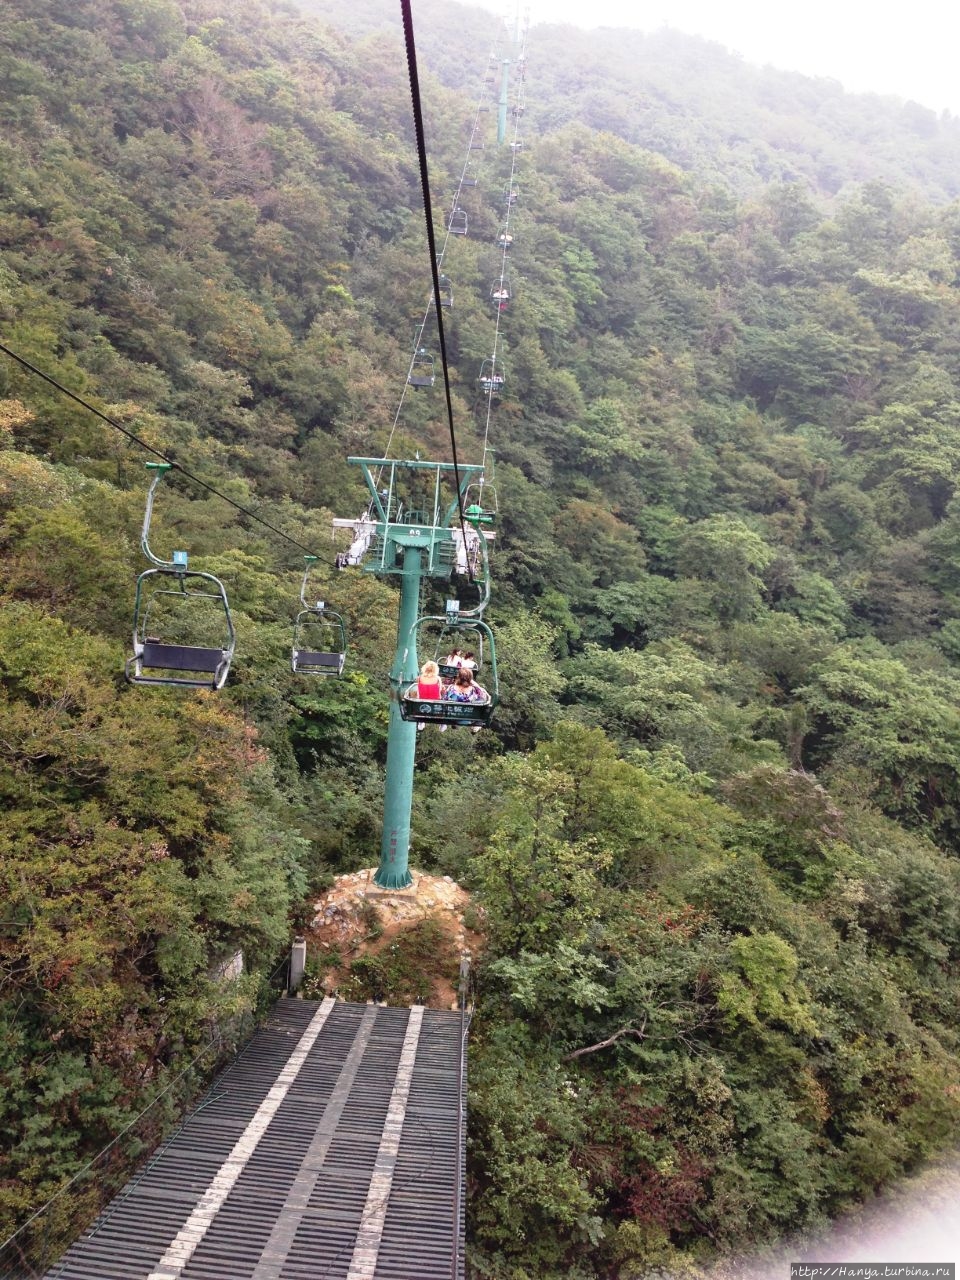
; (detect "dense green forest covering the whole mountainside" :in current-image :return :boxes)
[0,0,960,1280]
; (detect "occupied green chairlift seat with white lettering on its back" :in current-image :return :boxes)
[394,600,500,728]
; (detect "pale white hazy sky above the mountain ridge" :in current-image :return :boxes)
[529,0,960,115]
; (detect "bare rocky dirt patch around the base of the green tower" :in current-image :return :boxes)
[302,867,483,1009]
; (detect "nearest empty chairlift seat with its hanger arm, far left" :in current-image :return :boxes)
[124,462,237,689]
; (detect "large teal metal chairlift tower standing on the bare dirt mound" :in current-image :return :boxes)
[333,458,493,890]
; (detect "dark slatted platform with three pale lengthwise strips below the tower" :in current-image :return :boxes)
[47,998,467,1280]
